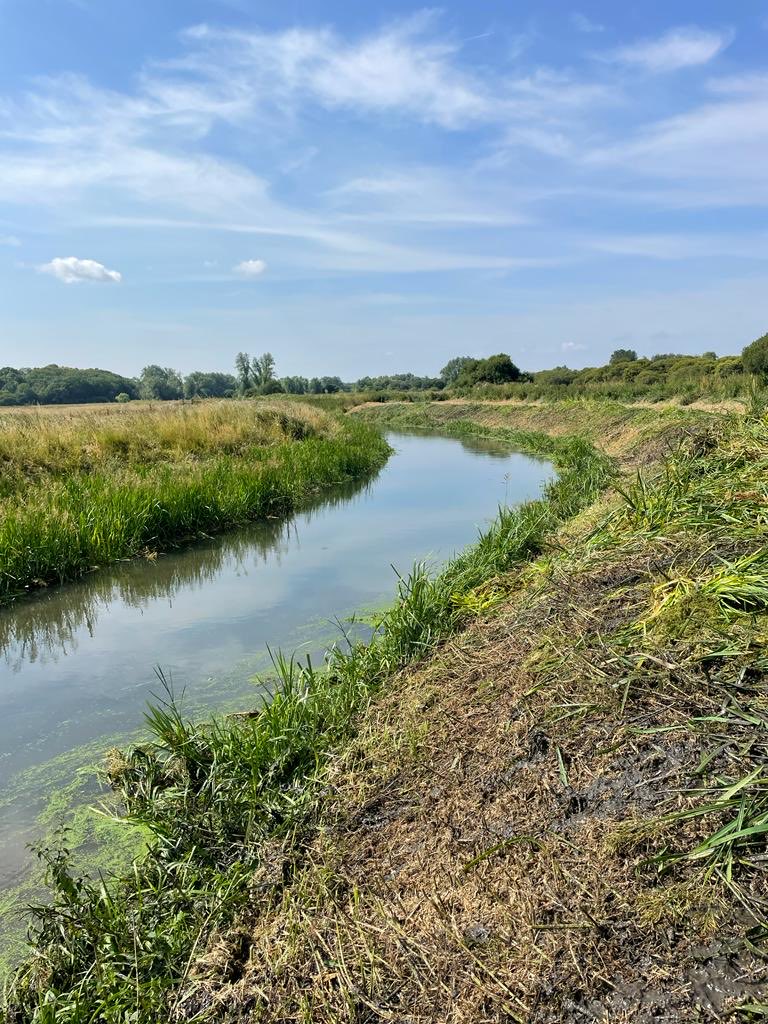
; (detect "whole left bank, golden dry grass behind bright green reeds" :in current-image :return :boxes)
[0,401,388,600]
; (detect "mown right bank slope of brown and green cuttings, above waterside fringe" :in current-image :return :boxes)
[182,407,768,1024]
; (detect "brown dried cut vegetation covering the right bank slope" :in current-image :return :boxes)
[178,501,768,1024]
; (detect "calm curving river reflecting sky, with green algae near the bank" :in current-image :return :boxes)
[0,434,552,966]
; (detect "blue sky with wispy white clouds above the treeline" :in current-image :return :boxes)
[0,0,768,379]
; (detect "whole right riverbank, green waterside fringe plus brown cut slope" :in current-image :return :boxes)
[4,403,768,1024]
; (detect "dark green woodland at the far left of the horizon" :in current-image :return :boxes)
[0,364,138,406]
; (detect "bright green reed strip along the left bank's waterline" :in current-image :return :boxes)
[0,403,391,607]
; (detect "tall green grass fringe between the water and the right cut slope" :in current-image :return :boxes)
[0,425,612,1024]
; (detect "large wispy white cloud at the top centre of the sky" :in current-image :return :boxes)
[169,16,610,130]
